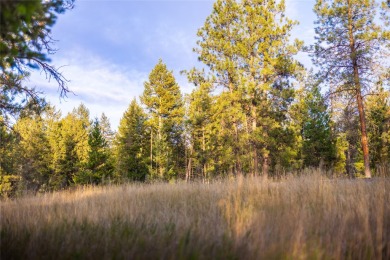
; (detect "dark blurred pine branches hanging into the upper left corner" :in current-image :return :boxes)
[0,0,74,117]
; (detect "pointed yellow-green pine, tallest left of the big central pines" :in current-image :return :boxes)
[141,60,185,180]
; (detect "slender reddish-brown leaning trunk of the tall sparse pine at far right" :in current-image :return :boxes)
[348,0,371,178]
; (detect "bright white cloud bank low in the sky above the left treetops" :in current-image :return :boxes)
[29,50,147,129]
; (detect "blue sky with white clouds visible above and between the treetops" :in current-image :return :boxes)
[29,0,315,130]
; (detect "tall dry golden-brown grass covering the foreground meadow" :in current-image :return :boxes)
[0,171,390,259]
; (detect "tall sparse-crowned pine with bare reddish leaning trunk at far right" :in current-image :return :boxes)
[312,0,390,178]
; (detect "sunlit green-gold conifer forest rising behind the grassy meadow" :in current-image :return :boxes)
[0,0,390,197]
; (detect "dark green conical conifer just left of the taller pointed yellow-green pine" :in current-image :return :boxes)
[114,99,149,181]
